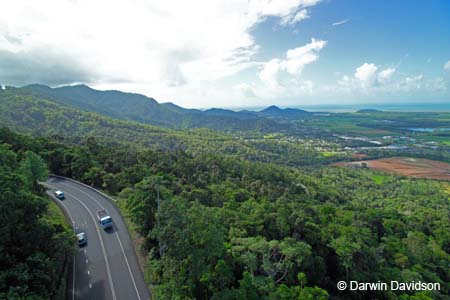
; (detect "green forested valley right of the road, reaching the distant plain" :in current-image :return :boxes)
[0,88,450,299]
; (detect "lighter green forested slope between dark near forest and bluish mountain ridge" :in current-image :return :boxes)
[0,88,340,165]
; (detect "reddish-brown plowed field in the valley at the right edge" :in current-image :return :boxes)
[334,157,450,180]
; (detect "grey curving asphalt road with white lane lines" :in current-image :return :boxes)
[45,177,150,300]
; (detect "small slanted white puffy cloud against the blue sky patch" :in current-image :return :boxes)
[259,39,327,87]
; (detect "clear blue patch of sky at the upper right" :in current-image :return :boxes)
[253,0,450,76]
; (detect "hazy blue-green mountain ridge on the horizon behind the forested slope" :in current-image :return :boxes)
[22,84,282,132]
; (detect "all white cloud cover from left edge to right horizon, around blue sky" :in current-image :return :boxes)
[0,0,450,107]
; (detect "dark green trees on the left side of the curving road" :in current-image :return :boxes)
[0,137,74,300]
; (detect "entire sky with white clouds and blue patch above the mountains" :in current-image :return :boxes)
[0,0,450,108]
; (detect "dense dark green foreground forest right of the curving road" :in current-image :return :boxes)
[0,129,450,299]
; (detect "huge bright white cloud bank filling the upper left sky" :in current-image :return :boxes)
[0,0,319,90]
